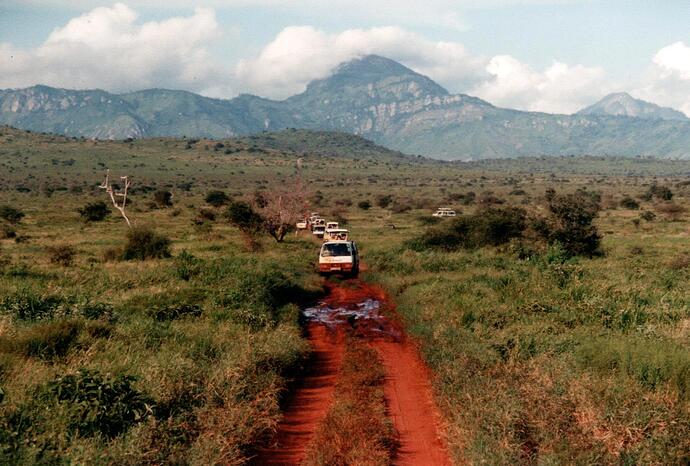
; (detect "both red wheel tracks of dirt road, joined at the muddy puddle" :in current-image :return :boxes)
[253,279,452,466]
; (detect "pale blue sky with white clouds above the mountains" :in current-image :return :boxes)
[0,0,690,115]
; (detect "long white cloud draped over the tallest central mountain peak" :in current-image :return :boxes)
[237,26,484,98]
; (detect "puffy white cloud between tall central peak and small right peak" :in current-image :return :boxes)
[470,55,611,113]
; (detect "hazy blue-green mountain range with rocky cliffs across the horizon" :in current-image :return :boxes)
[0,55,690,160]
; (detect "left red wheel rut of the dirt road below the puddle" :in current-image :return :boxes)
[251,324,344,466]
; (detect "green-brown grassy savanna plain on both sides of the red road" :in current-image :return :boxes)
[0,128,690,465]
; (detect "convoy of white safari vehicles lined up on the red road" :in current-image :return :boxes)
[297,212,359,277]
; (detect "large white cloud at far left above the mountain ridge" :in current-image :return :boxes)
[0,3,228,93]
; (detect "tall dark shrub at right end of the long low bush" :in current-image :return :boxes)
[540,191,601,257]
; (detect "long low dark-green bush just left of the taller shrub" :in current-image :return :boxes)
[407,207,526,250]
